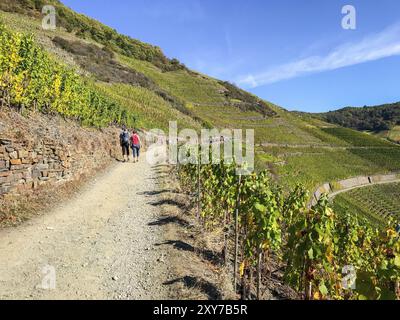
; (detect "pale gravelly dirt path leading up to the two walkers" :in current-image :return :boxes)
[0,157,169,299]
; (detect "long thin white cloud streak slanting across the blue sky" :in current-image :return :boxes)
[236,24,400,88]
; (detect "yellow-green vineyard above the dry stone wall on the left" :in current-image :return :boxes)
[0,25,136,127]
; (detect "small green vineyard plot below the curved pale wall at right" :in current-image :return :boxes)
[334,183,400,225]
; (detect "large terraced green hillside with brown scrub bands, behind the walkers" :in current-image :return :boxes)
[0,0,400,195]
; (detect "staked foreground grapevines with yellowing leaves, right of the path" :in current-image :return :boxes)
[177,151,400,300]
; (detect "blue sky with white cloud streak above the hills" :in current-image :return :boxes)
[62,0,400,112]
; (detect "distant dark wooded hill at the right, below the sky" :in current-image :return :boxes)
[318,102,400,142]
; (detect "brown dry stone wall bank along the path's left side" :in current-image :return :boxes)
[0,111,120,197]
